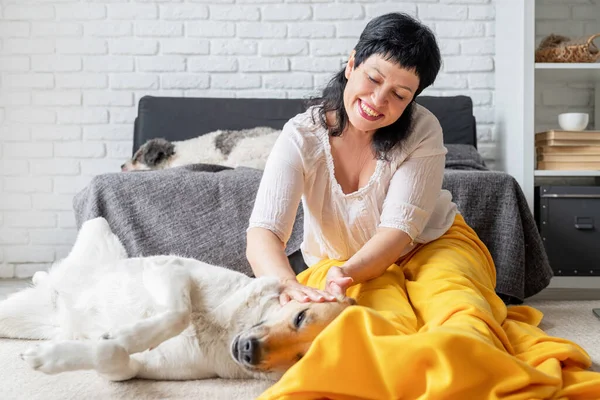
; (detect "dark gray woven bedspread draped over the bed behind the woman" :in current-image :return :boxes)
[73,145,552,303]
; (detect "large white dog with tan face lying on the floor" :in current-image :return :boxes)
[0,218,354,381]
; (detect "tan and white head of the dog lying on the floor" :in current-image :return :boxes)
[231,297,356,379]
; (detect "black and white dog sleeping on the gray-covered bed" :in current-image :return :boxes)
[121,126,281,172]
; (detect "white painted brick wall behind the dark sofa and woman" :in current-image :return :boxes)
[0,0,496,278]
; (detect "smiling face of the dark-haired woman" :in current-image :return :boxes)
[344,51,419,132]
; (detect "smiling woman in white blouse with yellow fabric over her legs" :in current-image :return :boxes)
[247,14,600,399]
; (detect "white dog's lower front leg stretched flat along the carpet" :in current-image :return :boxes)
[21,340,141,381]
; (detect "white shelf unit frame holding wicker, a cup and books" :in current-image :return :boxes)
[495,0,600,211]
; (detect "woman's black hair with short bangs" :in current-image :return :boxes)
[308,13,442,159]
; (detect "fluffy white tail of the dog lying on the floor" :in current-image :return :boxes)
[0,272,60,339]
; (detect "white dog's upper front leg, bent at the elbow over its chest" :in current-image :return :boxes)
[103,263,192,354]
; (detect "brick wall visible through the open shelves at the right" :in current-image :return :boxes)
[535,0,600,132]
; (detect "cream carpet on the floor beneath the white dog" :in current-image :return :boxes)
[0,282,600,400]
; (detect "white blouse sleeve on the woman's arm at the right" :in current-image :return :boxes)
[379,111,447,241]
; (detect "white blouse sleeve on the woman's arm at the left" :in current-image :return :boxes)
[248,123,304,245]
